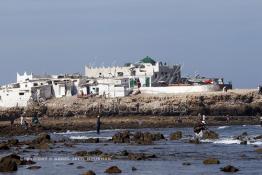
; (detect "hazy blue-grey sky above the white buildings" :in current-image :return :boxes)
[0,0,262,88]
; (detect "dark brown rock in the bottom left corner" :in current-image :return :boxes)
[0,155,20,172]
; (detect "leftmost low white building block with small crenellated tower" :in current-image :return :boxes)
[0,73,81,107]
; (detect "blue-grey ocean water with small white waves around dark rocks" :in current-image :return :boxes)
[1,125,262,175]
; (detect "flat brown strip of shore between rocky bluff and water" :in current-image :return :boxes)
[0,116,259,137]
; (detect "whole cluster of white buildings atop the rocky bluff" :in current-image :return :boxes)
[0,57,229,107]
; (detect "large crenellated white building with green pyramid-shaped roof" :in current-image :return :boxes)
[85,57,181,88]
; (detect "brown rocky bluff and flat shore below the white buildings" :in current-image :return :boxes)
[0,90,262,135]
